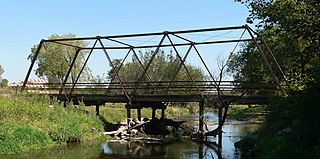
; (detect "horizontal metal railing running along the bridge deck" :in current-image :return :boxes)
[44,81,280,95]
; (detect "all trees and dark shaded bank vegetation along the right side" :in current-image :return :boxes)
[232,0,320,158]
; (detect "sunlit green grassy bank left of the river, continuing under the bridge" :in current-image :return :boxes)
[0,90,189,154]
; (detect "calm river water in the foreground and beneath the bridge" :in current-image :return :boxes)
[0,112,260,159]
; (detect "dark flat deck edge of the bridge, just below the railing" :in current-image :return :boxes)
[50,94,269,106]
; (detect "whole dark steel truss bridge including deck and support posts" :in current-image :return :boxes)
[22,25,284,158]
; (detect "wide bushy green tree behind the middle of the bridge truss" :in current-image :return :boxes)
[108,51,206,94]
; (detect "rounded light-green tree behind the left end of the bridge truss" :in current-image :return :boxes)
[28,33,91,83]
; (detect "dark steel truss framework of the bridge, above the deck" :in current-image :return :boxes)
[22,25,284,103]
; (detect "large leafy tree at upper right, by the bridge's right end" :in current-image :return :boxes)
[229,0,320,89]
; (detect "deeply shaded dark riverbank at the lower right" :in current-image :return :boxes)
[236,88,320,159]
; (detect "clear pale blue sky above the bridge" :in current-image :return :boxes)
[0,0,249,83]
